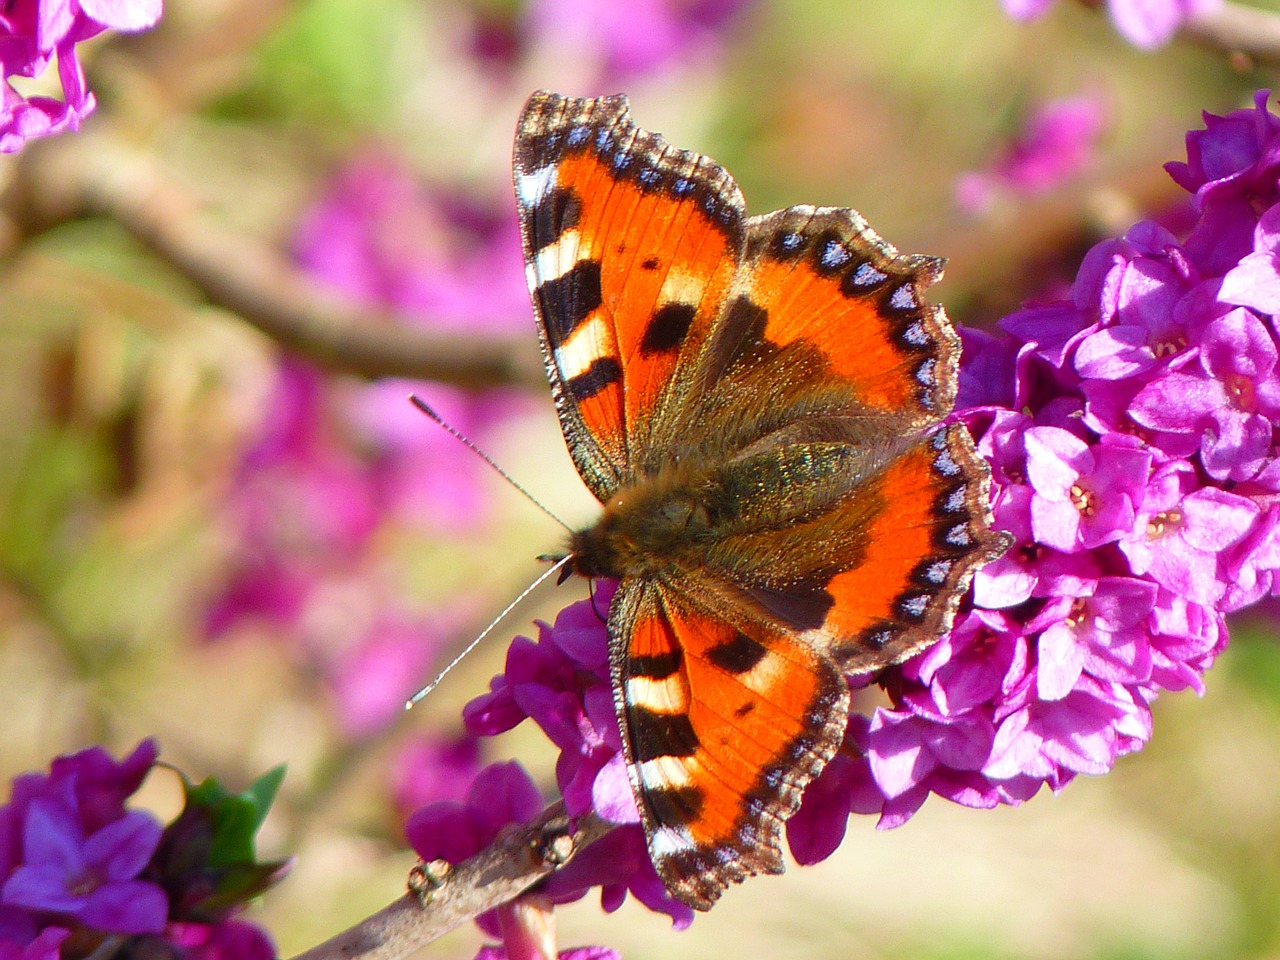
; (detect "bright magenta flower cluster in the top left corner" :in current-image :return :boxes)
[0,0,163,154]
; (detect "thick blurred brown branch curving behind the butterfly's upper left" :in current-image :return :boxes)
[13,125,547,390]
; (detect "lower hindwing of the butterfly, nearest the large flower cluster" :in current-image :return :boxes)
[705,425,1004,673]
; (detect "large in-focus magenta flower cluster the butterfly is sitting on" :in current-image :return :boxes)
[404,92,1280,923]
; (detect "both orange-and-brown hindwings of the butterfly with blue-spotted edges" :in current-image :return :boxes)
[681,212,1004,672]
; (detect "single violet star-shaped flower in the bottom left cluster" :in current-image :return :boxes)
[0,776,169,933]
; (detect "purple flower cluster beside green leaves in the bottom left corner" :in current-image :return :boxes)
[0,740,275,960]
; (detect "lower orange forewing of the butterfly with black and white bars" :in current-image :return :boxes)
[609,580,849,909]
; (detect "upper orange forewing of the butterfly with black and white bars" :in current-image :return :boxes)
[515,93,745,500]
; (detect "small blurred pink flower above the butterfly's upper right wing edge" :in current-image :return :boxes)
[956,95,1107,212]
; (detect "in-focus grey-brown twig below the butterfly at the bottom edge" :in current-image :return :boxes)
[286,803,612,960]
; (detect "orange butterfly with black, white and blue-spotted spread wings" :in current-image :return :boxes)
[513,92,1005,910]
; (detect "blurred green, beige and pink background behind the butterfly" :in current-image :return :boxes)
[0,0,1280,960]
